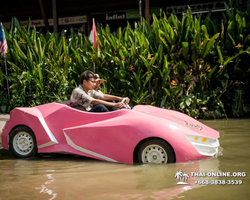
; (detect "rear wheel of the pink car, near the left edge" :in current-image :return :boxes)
[9,126,37,158]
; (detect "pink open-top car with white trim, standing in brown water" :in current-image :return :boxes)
[1,102,219,164]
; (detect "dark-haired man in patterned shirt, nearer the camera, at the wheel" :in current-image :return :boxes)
[70,70,130,112]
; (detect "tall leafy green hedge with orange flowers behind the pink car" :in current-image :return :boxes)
[0,5,250,118]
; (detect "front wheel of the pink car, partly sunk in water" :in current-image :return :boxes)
[137,139,175,164]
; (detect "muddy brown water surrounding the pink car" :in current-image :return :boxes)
[0,119,250,200]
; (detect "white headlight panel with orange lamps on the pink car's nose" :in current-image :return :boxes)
[186,135,220,156]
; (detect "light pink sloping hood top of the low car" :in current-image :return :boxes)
[133,105,220,138]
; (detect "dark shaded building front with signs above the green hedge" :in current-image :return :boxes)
[0,0,247,34]
